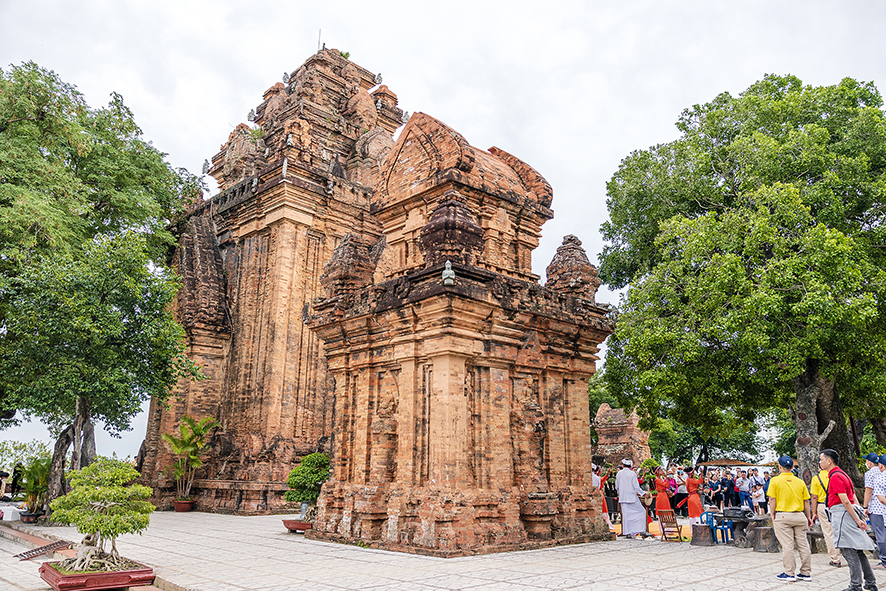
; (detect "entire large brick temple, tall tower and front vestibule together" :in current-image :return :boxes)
[145,50,614,556]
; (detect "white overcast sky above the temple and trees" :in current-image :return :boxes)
[0,0,886,456]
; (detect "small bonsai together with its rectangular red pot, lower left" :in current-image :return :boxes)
[40,457,154,590]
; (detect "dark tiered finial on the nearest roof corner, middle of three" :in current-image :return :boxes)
[418,190,483,266]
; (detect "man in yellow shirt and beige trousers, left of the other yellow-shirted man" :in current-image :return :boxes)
[767,456,812,581]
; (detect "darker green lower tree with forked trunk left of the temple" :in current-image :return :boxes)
[0,232,199,499]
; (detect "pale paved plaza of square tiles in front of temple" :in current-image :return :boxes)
[0,512,886,591]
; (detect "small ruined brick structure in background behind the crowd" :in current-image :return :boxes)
[594,402,652,467]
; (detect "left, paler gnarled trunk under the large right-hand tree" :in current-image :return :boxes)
[791,362,845,484]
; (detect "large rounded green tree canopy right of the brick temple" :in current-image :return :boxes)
[601,75,886,480]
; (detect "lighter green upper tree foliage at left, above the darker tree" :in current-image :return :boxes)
[0,62,202,428]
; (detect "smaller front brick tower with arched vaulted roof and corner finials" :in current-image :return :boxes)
[308,113,614,556]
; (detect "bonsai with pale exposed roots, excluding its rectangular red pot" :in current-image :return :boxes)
[50,457,154,572]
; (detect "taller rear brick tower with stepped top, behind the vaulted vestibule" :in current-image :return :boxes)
[142,50,402,513]
